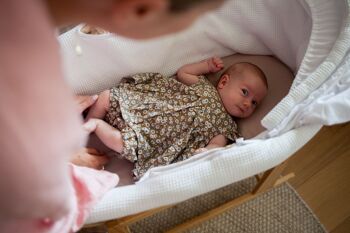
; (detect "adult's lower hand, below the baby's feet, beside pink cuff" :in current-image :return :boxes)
[70,148,109,170]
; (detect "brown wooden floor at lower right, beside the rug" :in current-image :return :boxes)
[284,123,350,233]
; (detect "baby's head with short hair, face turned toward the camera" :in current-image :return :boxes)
[217,69,267,118]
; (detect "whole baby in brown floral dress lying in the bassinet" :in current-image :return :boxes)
[85,57,268,178]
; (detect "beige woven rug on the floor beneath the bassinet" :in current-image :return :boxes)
[130,178,326,233]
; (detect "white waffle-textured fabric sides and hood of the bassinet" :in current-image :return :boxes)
[59,0,350,230]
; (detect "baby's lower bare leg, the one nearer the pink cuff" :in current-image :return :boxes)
[84,118,123,153]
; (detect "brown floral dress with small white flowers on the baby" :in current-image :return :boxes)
[105,73,238,178]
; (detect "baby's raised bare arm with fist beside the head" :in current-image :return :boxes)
[177,57,224,86]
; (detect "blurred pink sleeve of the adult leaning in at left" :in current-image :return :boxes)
[0,0,86,220]
